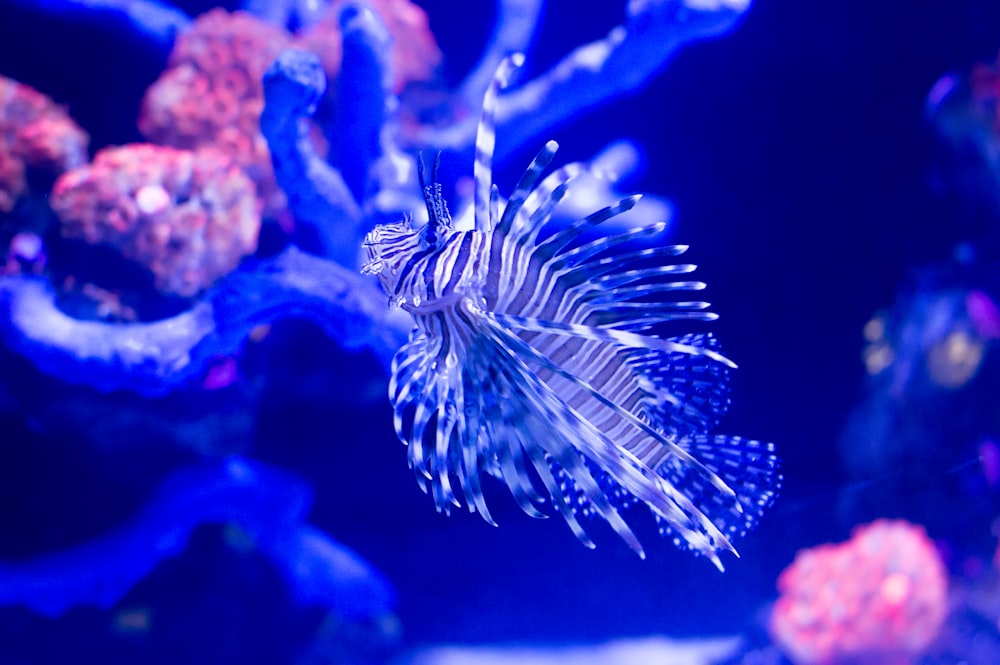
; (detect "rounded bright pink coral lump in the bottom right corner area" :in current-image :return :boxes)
[770,520,947,665]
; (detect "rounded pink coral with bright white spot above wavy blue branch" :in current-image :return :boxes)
[51,144,260,296]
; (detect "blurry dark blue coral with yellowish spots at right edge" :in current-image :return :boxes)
[840,274,1000,546]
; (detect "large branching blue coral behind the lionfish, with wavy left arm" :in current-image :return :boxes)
[0,0,748,395]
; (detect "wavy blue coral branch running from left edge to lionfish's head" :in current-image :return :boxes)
[0,248,408,396]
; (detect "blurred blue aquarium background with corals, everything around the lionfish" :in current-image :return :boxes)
[0,0,1000,665]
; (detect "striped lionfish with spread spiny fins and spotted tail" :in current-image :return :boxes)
[363,55,780,569]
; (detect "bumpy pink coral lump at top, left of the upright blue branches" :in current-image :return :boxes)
[139,9,291,215]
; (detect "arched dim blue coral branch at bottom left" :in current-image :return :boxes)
[0,457,395,620]
